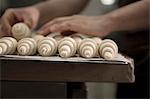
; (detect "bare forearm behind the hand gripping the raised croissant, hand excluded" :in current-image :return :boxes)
[33,0,88,23]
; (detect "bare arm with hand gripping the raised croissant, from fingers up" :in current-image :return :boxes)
[0,0,88,37]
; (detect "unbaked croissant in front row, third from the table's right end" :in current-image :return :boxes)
[58,37,77,58]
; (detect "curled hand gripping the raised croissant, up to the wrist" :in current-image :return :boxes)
[0,7,40,37]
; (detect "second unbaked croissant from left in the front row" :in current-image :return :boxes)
[17,38,37,56]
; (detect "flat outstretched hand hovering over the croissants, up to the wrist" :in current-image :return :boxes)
[38,15,111,37]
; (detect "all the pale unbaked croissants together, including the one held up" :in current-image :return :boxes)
[0,23,118,59]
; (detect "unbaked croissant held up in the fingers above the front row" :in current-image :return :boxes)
[12,23,31,40]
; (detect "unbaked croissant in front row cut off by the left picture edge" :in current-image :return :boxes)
[0,37,17,55]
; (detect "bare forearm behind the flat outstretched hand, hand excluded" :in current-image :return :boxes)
[105,0,150,32]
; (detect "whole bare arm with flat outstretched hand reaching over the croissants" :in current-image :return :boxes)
[39,0,150,37]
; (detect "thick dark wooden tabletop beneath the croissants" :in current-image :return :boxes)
[0,56,134,98]
